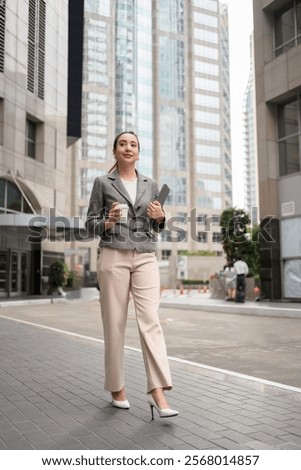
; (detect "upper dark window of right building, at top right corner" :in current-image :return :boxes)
[274,0,301,56]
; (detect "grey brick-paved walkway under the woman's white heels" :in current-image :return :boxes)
[0,299,301,450]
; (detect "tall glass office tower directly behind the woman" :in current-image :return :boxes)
[79,0,232,276]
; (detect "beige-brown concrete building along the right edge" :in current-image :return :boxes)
[253,0,301,300]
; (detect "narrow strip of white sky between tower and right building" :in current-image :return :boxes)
[220,0,253,208]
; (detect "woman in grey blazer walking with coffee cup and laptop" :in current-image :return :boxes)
[86,132,178,419]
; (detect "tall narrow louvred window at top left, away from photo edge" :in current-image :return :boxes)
[27,0,46,99]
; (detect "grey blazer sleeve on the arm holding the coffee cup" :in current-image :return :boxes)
[85,178,106,237]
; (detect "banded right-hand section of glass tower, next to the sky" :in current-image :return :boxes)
[192,0,232,235]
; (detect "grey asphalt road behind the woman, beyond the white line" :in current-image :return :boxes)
[0,300,301,388]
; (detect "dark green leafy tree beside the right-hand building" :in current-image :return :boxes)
[220,207,260,279]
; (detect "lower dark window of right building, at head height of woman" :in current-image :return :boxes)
[278,98,301,176]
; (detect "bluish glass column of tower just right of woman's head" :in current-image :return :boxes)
[157,0,185,206]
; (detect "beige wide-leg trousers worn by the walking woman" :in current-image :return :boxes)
[97,247,172,393]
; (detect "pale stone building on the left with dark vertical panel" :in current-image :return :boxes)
[0,0,81,296]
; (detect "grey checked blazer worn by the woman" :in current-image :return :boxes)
[86,170,165,252]
